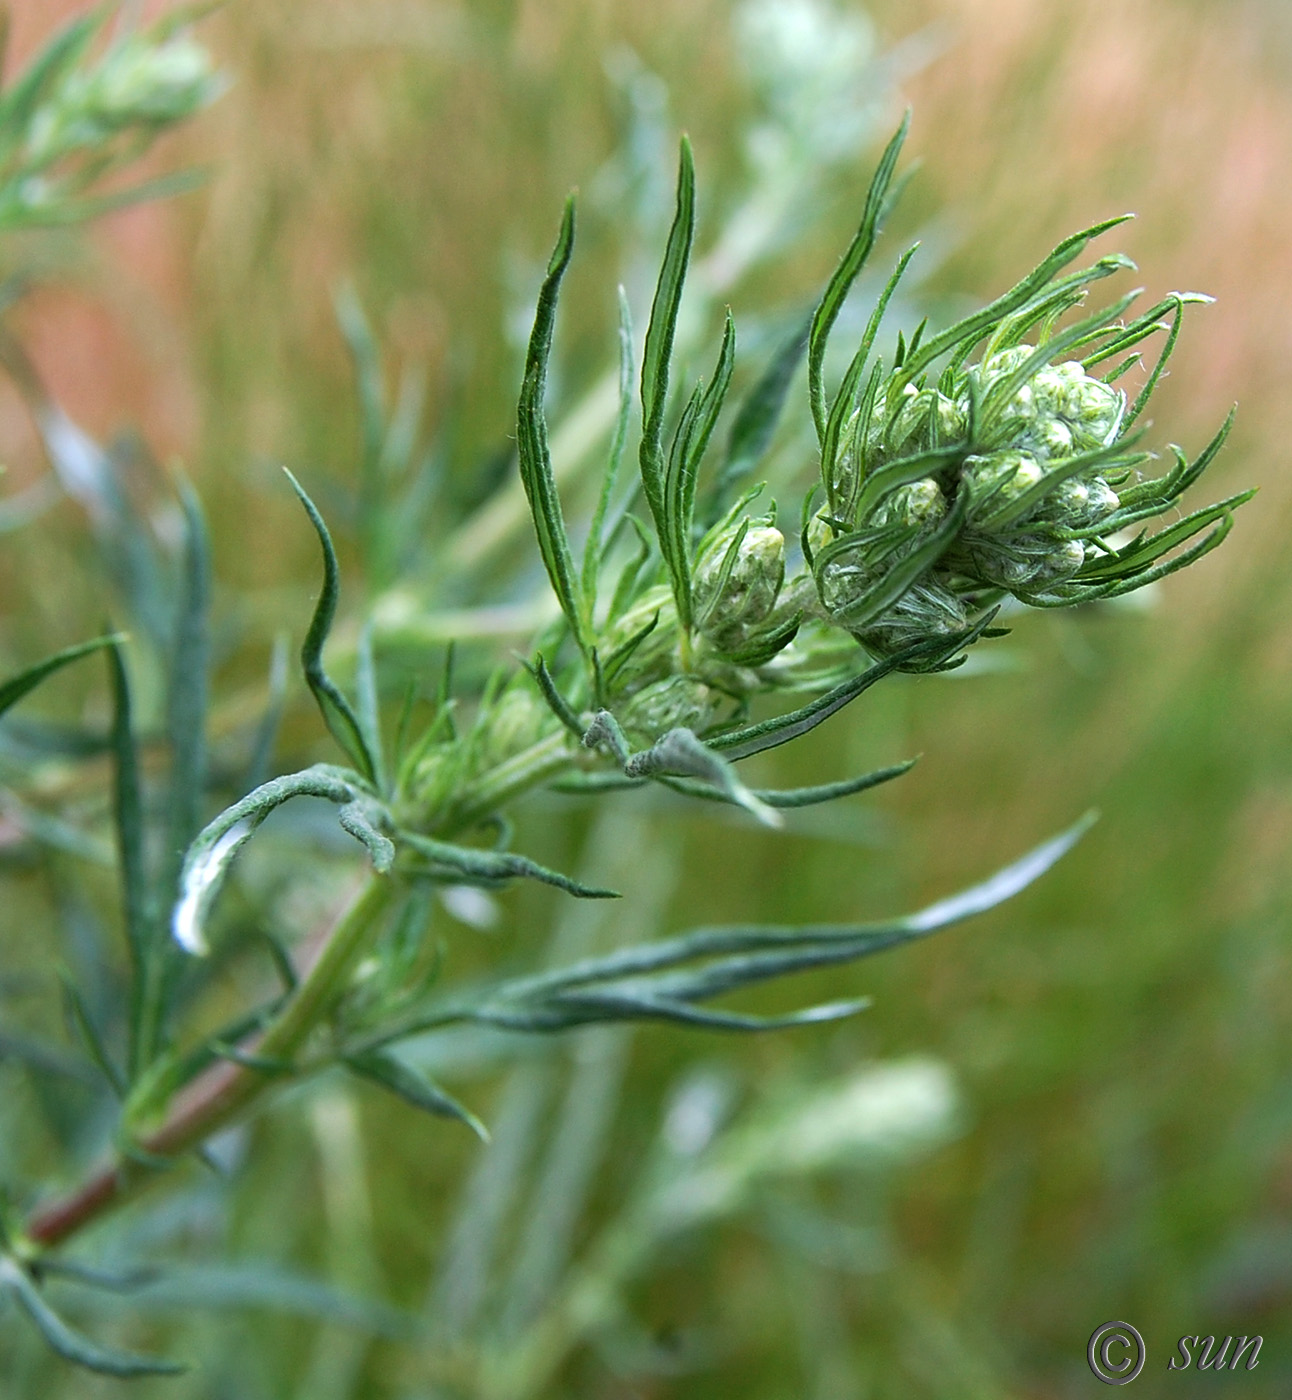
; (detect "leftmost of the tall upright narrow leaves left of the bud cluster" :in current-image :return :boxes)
[517,195,591,655]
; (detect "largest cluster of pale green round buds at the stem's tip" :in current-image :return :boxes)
[809,344,1128,654]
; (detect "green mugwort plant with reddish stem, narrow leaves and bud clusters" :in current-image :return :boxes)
[0,0,1247,1376]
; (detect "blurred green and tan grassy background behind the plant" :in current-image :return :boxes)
[0,0,1292,1400]
